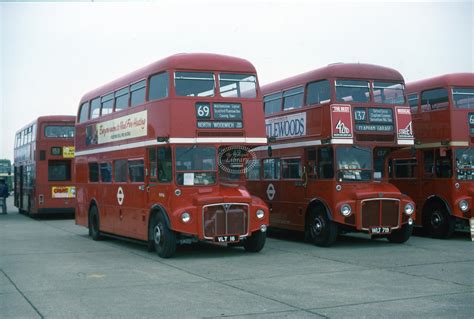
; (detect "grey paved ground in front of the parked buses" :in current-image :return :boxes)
[0,197,474,318]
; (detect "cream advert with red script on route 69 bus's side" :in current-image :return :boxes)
[97,111,147,144]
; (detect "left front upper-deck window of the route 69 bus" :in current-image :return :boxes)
[174,72,215,96]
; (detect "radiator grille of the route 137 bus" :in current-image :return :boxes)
[361,199,399,229]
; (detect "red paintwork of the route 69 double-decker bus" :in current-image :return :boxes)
[72,54,269,245]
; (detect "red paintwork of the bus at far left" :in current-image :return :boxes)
[14,115,76,215]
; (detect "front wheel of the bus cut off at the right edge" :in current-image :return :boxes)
[423,203,455,238]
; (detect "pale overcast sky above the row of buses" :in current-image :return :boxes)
[0,0,474,158]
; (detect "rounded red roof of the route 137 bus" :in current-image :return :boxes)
[262,63,403,95]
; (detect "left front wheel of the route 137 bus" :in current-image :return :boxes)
[307,206,337,247]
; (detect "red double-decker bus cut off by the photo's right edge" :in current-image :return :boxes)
[391,73,474,238]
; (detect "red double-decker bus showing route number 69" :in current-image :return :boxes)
[75,54,269,257]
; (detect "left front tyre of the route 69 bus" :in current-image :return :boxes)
[150,213,176,258]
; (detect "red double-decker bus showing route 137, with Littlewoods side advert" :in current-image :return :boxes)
[247,64,414,246]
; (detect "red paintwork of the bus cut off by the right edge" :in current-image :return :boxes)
[392,73,474,225]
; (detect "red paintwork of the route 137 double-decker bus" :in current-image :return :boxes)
[247,64,413,238]
